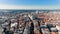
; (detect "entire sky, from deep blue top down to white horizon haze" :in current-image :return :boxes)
[0,0,60,9]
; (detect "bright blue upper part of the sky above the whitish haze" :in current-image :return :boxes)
[0,0,60,6]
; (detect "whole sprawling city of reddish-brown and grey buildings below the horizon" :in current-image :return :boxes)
[0,9,60,34]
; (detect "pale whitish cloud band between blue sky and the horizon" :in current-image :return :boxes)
[0,5,60,10]
